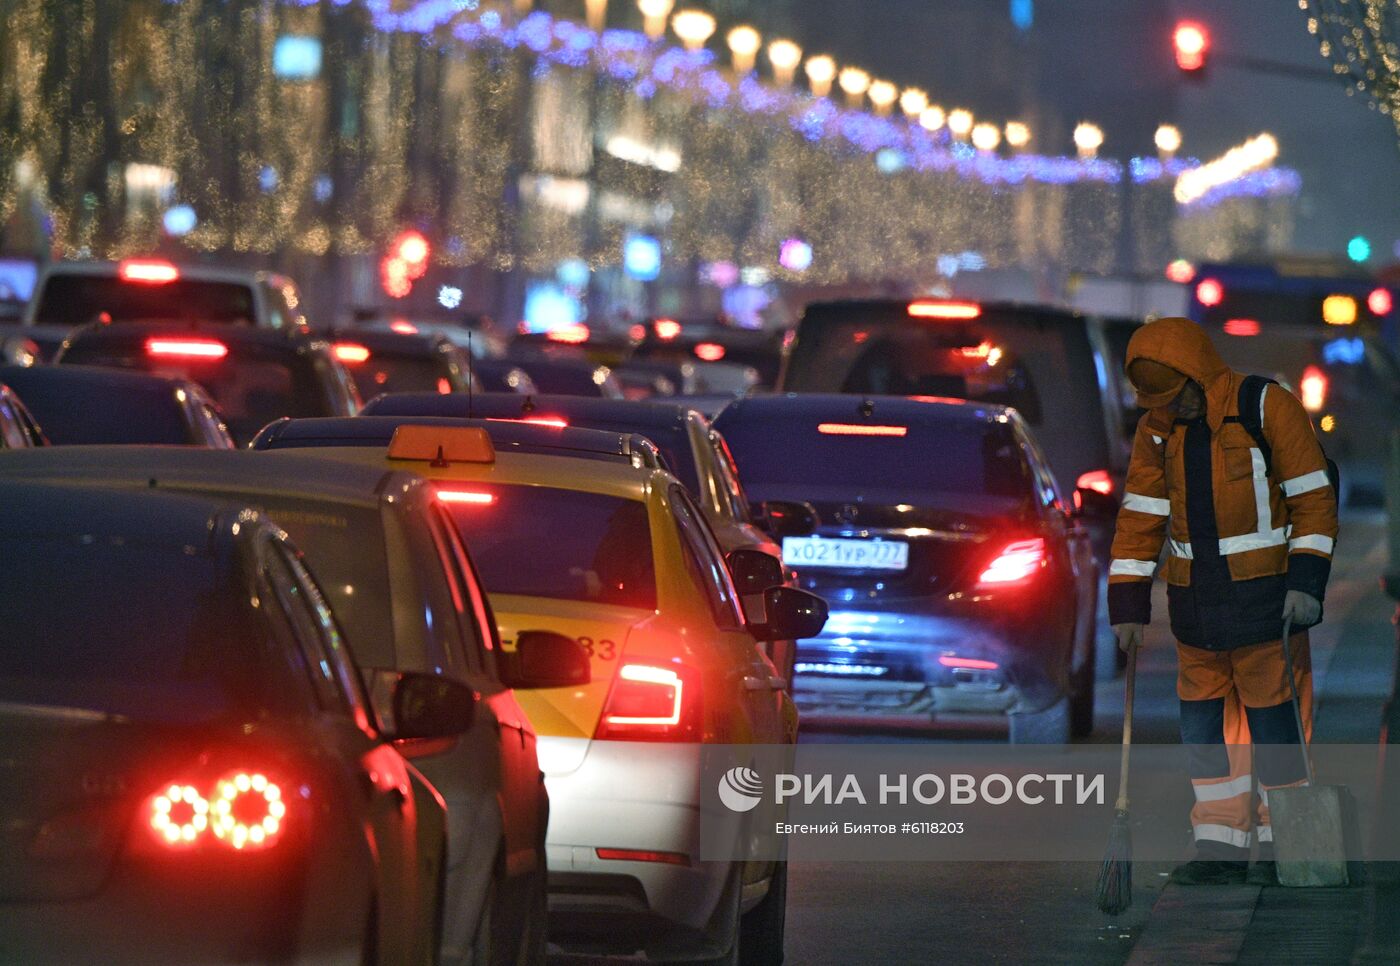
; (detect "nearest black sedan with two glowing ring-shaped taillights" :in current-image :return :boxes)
[0,483,476,963]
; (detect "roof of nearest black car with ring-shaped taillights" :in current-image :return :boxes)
[0,473,239,556]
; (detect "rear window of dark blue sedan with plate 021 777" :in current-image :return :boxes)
[718,413,1030,503]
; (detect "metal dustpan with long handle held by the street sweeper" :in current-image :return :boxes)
[1268,620,1354,886]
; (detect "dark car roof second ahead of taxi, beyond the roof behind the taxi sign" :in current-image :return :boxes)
[364,392,696,434]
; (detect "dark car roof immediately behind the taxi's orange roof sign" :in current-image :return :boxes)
[252,416,651,465]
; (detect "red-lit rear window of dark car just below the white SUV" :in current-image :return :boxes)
[63,340,330,444]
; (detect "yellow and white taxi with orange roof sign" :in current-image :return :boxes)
[253,417,826,963]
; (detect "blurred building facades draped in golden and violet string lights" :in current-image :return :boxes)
[0,0,1298,328]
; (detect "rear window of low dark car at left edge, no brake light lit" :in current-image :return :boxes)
[11,370,196,445]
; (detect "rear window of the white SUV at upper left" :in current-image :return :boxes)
[35,273,256,325]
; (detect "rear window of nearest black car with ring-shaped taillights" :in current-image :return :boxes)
[0,536,267,721]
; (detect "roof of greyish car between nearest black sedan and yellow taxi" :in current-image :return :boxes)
[0,445,420,507]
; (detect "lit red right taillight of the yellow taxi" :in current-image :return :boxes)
[594,664,700,741]
